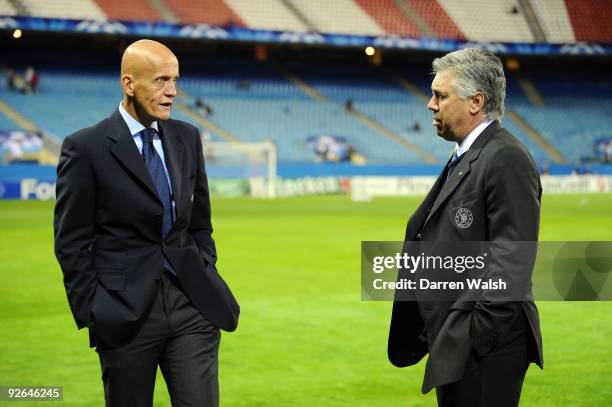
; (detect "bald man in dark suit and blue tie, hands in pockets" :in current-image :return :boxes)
[54,40,239,407]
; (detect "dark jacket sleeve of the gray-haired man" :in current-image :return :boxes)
[471,146,541,356]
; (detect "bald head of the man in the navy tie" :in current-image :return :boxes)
[121,40,179,127]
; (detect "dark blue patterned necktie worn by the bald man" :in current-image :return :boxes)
[140,127,176,274]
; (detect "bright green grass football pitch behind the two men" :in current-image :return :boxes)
[0,194,612,407]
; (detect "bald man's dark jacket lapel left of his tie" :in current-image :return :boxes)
[106,109,161,202]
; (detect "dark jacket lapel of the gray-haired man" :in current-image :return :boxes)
[423,120,501,226]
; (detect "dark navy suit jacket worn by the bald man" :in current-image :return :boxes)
[54,110,239,346]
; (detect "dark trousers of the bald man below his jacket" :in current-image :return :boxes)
[96,273,221,407]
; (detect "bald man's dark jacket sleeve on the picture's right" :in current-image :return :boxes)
[188,128,217,264]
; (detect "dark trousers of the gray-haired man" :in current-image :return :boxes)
[436,312,533,407]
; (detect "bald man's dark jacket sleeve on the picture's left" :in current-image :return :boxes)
[53,136,98,329]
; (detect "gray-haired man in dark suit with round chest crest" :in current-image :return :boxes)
[388,48,543,407]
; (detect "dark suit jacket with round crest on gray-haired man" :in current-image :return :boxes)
[388,121,543,393]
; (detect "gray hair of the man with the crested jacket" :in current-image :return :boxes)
[432,48,506,120]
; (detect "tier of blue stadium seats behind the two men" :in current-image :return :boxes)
[7,48,610,167]
